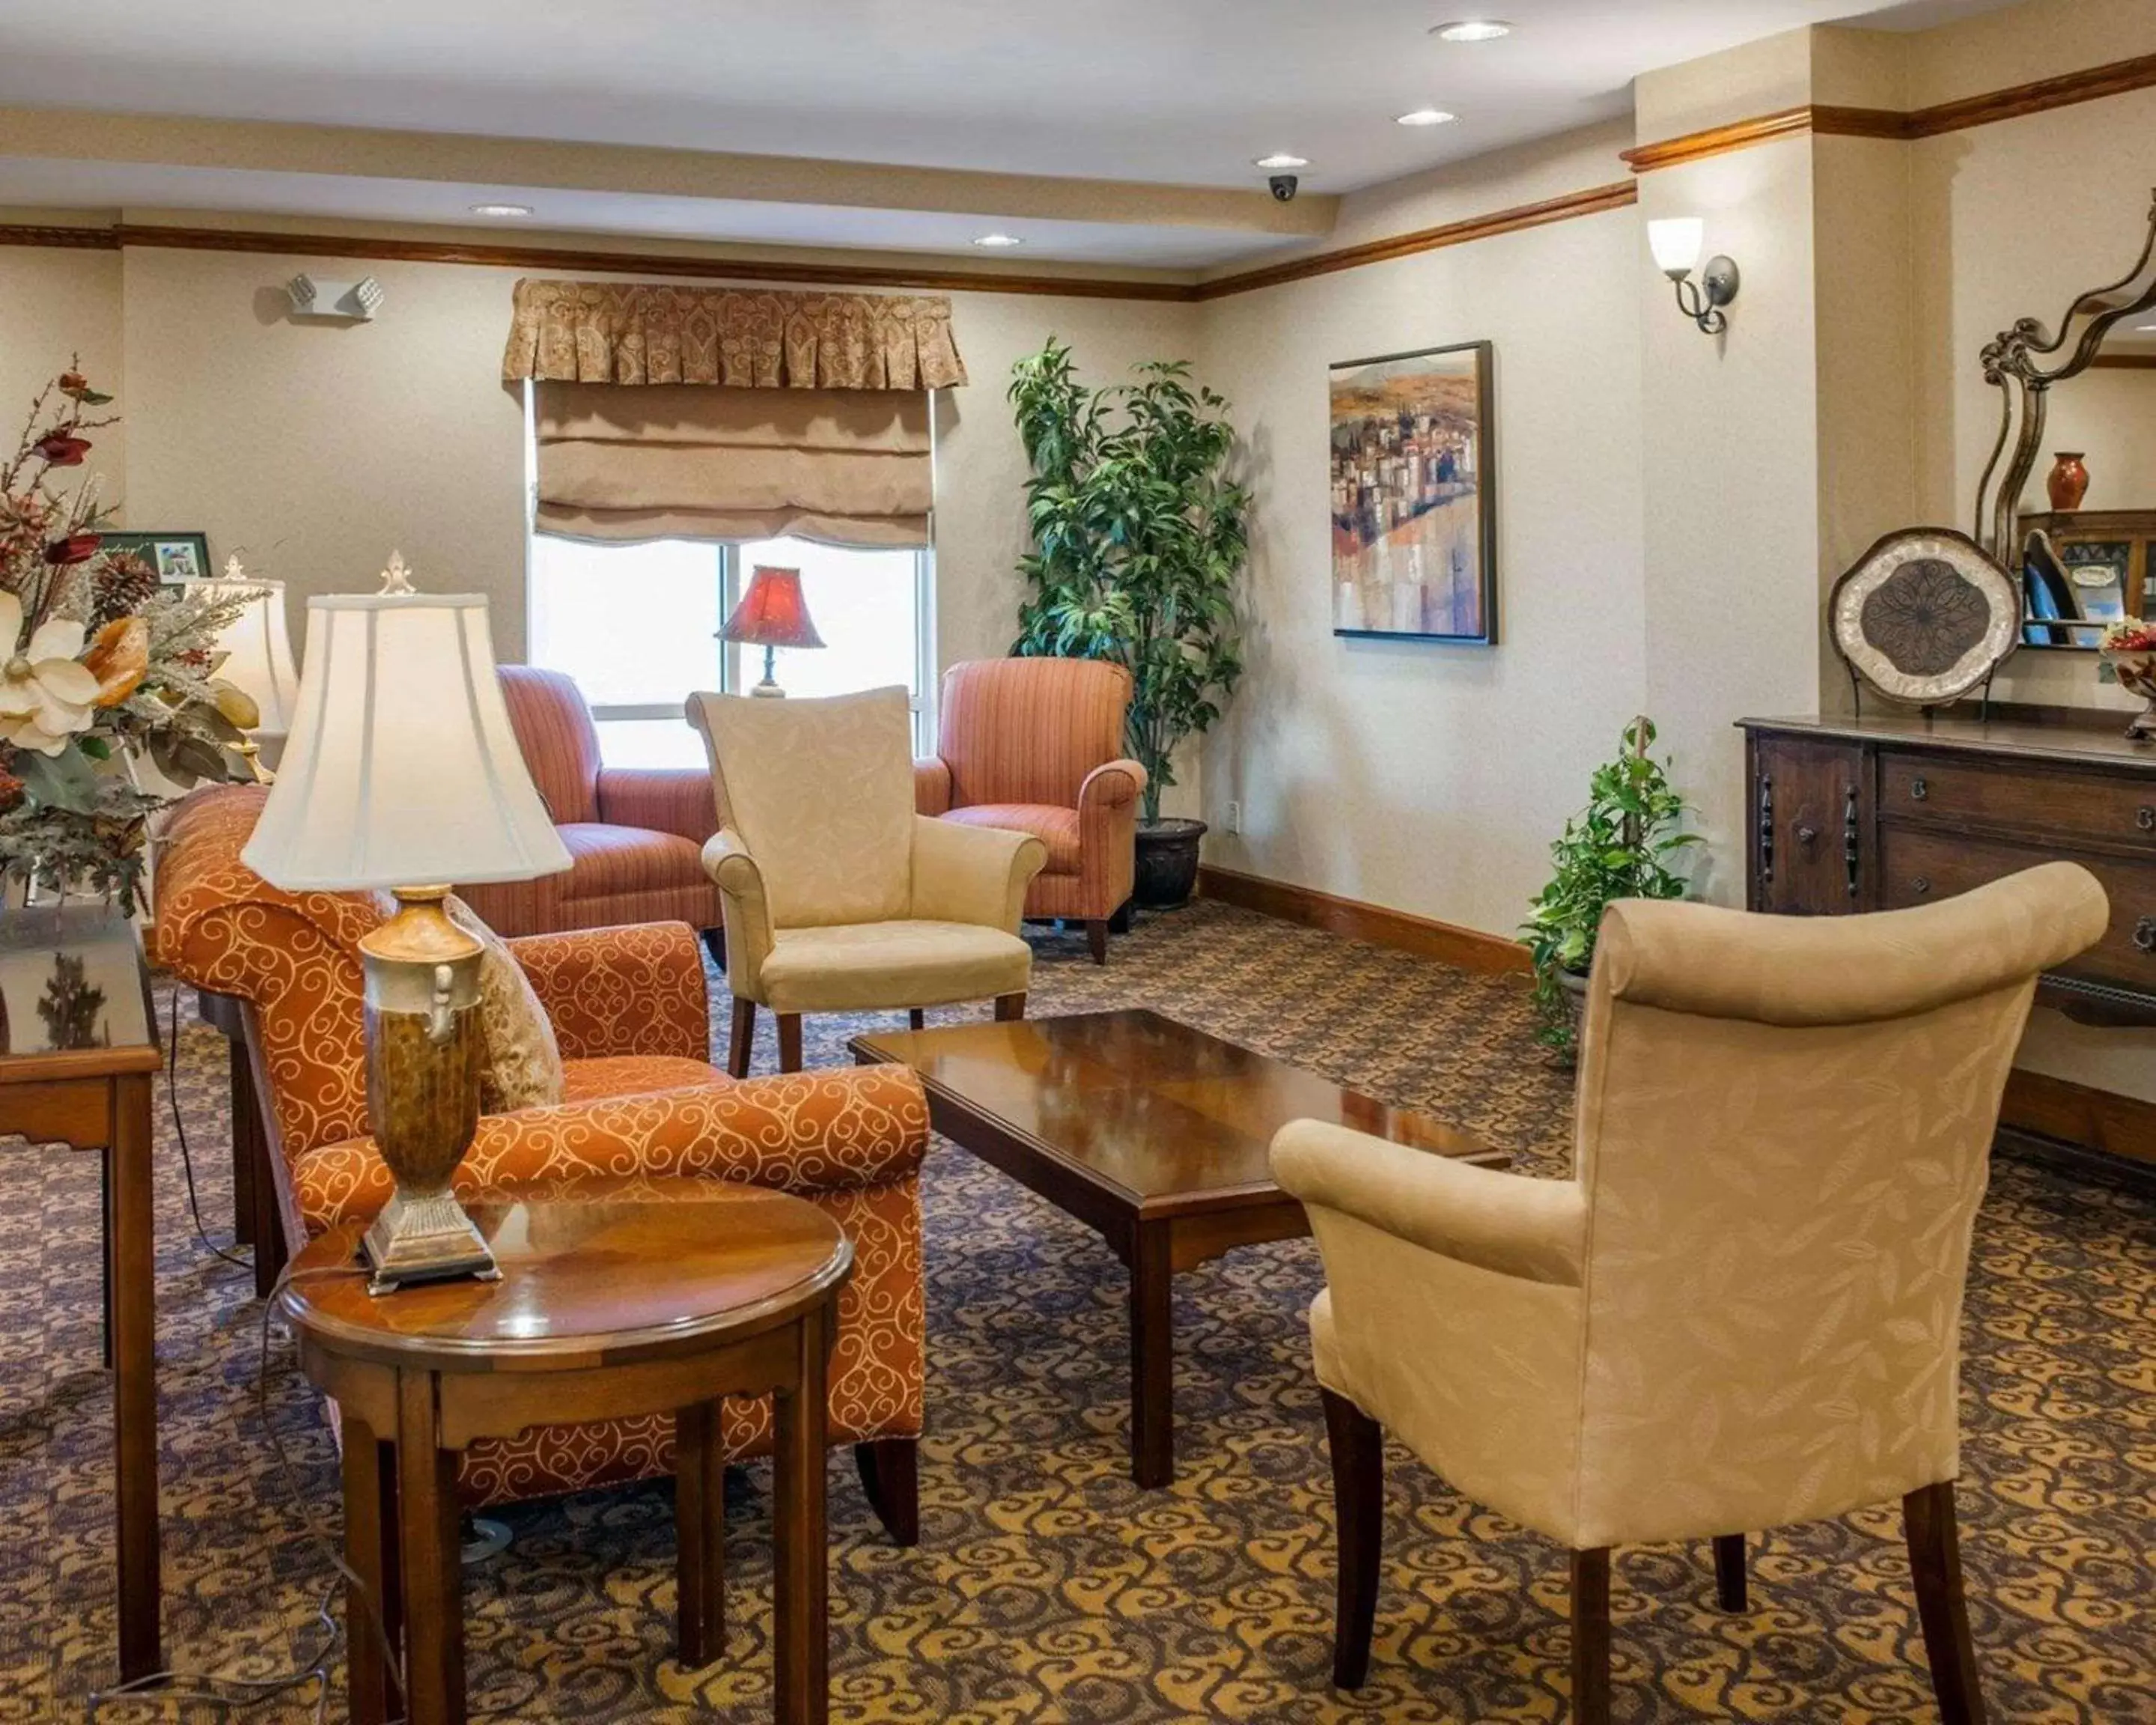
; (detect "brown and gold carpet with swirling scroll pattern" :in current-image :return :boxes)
[0,906,2156,1725]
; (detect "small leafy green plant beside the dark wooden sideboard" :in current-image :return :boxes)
[1520,714,1699,1059]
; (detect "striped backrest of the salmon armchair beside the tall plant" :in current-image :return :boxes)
[936,660,1130,809]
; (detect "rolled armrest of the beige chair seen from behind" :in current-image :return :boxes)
[1272,1119,1587,1287]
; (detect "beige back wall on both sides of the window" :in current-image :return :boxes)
[0,236,1196,806]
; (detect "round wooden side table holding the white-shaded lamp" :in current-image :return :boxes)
[280,1179,853,1725]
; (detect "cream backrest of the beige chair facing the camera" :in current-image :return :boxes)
[688,688,914,929]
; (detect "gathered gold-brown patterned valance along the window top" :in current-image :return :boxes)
[502,280,966,390]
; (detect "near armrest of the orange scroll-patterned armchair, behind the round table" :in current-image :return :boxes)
[296,1065,929,1231]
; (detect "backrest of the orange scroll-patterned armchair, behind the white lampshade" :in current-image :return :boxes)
[155,785,392,1158]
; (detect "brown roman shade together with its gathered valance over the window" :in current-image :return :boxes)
[502,280,966,548]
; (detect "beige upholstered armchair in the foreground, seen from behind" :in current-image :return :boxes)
[1272,862,2109,1725]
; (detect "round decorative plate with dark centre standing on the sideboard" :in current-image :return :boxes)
[1826,526,2021,708]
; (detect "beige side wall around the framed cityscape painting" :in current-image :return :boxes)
[1201,130,1645,931]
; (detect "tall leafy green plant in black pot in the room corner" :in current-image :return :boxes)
[1011,336,1250,907]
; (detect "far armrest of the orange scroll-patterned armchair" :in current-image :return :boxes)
[507,923,711,1061]
